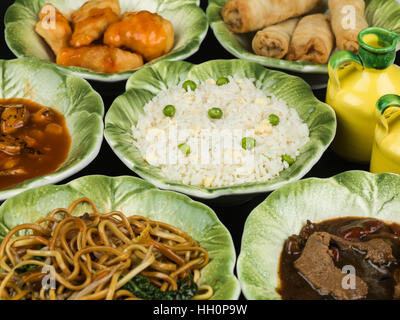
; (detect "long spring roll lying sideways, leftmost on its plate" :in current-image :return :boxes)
[221,0,322,33]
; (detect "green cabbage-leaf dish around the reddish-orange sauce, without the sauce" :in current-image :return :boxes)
[0,58,104,200]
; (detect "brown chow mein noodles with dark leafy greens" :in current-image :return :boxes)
[0,198,213,300]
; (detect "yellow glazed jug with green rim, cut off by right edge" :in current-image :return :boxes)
[370,94,400,174]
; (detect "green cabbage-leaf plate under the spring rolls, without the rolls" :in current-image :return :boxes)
[207,0,400,73]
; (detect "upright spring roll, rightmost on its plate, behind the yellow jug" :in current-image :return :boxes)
[328,0,368,53]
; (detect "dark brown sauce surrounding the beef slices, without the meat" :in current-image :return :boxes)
[277,217,400,300]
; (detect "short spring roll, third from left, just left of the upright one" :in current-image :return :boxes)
[286,13,335,64]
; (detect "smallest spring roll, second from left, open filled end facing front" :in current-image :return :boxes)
[252,18,299,59]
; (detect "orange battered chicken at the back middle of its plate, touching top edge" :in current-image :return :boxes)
[70,0,121,47]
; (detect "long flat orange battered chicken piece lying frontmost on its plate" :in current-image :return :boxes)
[57,45,143,73]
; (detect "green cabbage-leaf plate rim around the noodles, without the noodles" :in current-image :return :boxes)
[0,176,240,300]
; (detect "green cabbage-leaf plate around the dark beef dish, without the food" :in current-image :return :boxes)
[237,171,400,300]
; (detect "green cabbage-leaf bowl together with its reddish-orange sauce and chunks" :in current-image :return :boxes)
[0,58,104,201]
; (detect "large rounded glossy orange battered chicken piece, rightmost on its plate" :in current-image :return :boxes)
[104,11,174,61]
